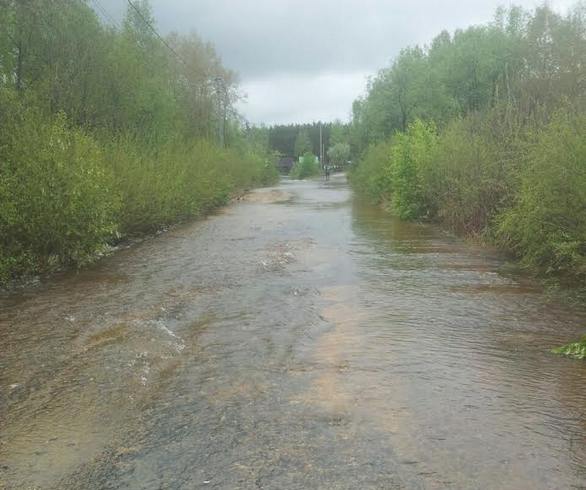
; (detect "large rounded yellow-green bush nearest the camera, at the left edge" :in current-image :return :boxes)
[0,97,119,280]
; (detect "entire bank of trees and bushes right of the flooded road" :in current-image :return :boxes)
[350,3,586,284]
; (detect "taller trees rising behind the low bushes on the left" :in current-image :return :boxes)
[0,0,237,140]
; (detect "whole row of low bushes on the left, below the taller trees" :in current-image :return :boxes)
[0,92,278,284]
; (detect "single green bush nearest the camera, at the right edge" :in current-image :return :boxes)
[497,115,586,280]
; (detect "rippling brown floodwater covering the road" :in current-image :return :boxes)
[0,176,586,490]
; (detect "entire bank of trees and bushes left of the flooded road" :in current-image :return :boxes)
[0,0,276,282]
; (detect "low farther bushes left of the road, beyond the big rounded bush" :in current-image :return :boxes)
[109,139,277,234]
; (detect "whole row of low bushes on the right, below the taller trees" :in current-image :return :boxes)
[351,108,586,281]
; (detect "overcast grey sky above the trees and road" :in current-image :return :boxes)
[101,0,575,124]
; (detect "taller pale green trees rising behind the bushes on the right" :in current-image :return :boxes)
[350,4,586,154]
